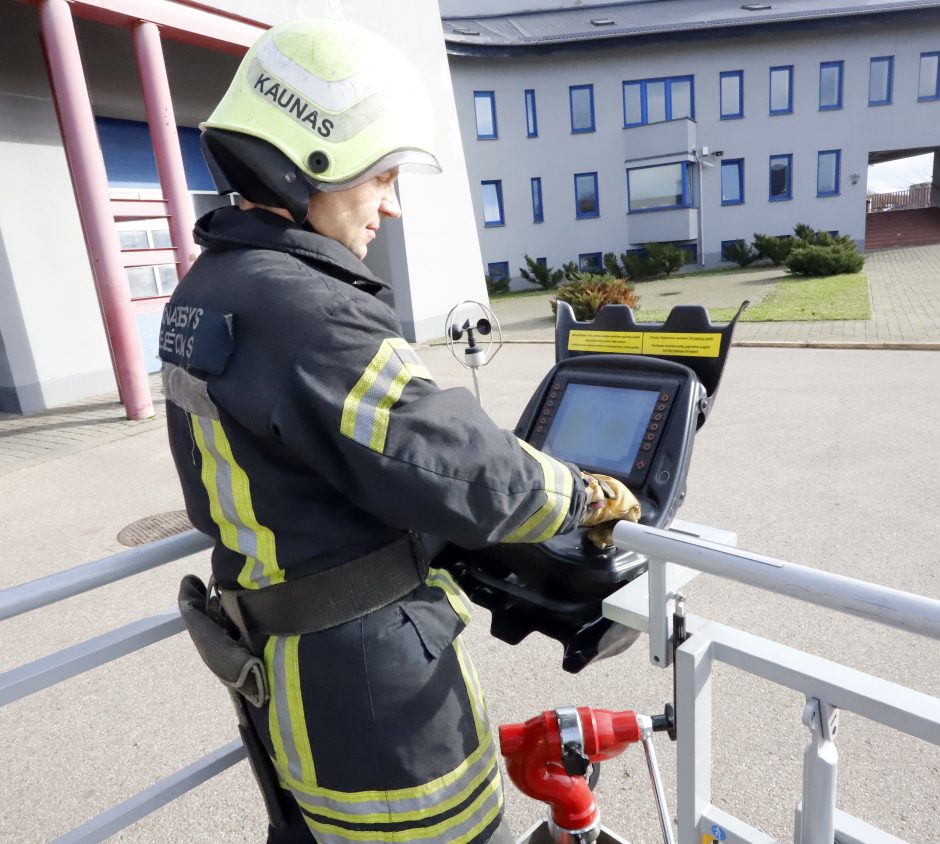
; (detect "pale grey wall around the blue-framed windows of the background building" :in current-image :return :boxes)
[450,18,940,274]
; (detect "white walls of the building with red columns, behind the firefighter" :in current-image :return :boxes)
[0,0,486,413]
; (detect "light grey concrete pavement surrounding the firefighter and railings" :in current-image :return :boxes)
[0,247,940,844]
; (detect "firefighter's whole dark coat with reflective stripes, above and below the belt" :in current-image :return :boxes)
[160,208,585,844]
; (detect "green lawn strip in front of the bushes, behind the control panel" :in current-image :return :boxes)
[636,273,871,322]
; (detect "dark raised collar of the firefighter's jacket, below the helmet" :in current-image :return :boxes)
[193,207,390,293]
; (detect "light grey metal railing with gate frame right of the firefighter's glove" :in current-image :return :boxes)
[604,522,940,844]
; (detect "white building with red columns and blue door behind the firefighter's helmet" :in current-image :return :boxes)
[0,0,485,418]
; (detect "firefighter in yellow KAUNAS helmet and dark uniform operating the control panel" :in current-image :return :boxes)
[160,20,638,844]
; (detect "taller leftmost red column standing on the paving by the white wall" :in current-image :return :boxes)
[39,0,153,419]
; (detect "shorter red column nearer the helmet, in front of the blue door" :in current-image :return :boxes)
[134,21,196,278]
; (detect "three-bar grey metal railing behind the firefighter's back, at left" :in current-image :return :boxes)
[0,530,245,844]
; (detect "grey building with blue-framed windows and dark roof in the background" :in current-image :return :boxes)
[444,0,940,284]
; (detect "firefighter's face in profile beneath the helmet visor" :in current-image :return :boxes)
[307,167,401,260]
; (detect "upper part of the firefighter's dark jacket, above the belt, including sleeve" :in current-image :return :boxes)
[160,208,584,589]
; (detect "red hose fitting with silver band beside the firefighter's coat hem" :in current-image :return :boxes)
[499,706,640,831]
